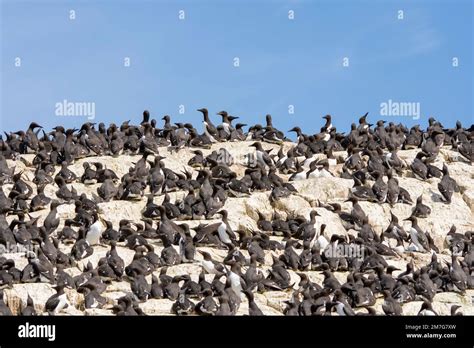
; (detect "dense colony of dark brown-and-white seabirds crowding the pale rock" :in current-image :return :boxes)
[0,108,474,315]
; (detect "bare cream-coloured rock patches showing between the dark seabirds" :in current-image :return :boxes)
[2,141,474,315]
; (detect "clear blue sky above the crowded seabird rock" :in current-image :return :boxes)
[0,0,474,137]
